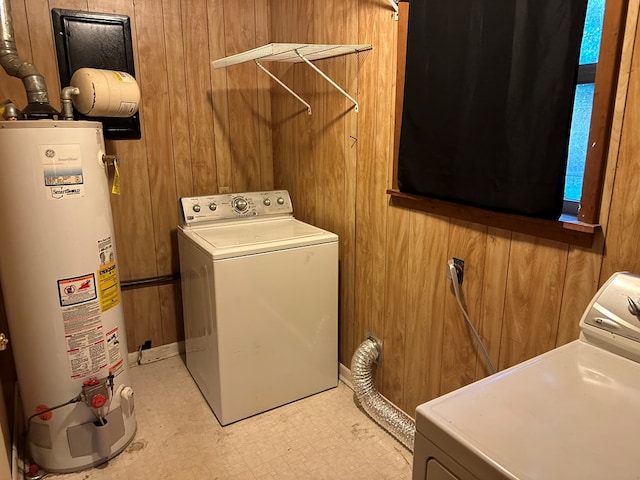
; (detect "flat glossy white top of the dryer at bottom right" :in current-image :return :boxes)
[416,340,640,480]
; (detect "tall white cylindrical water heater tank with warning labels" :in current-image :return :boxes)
[0,120,136,472]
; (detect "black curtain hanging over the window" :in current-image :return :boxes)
[398,0,587,219]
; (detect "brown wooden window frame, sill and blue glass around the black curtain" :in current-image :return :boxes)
[388,0,628,247]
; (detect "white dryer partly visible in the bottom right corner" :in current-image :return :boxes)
[413,273,640,480]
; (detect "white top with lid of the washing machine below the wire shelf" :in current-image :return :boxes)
[191,217,338,259]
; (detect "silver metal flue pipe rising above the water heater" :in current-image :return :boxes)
[0,0,49,105]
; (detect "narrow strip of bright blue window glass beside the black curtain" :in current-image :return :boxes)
[564,0,605,215]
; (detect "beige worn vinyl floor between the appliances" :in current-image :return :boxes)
[47,356,412,480]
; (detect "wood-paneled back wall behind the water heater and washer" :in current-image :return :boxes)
[0,0,273,351]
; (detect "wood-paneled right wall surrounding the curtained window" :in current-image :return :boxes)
[271,0,640,413]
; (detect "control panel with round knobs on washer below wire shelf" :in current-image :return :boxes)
[180,190,293,226]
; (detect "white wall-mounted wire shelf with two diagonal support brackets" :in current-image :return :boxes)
[211,43,371,115]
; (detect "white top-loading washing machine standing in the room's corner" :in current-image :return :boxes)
[178,190,338,425]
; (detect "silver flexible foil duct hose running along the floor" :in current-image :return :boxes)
[351,338,416,452]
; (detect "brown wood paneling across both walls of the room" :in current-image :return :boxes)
[0,0,640,413]
